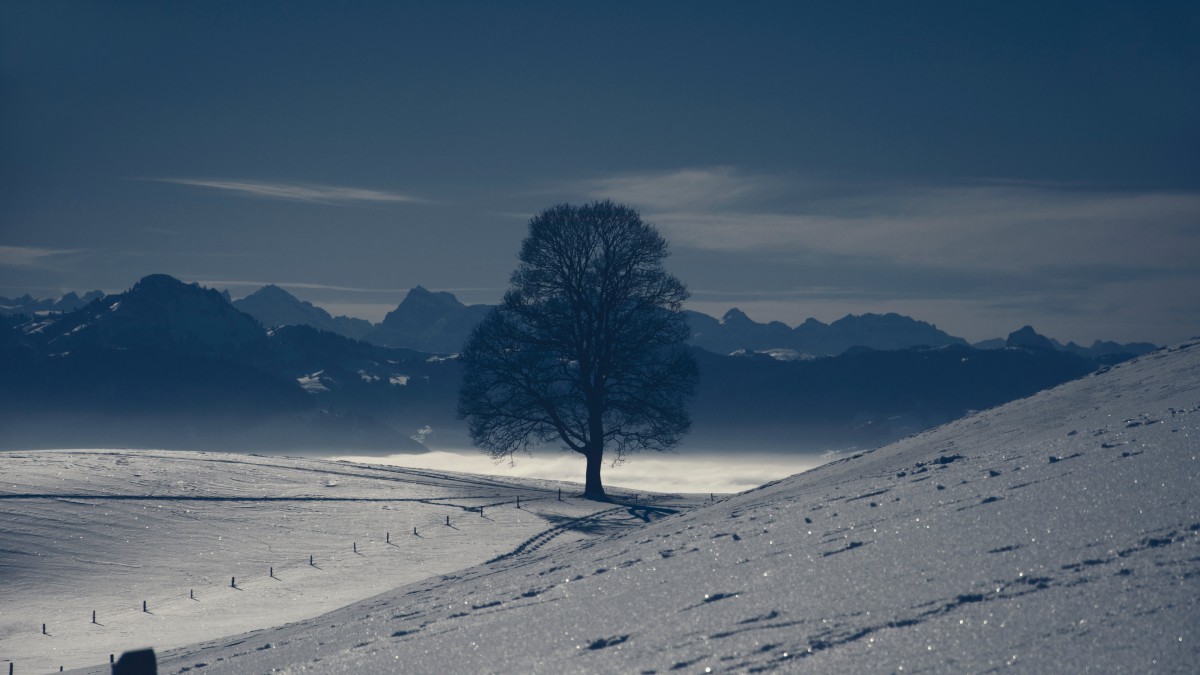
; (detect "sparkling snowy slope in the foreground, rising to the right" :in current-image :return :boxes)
[58,344,1200,674]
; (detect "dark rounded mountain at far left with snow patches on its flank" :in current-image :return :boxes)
[0,275,432,452]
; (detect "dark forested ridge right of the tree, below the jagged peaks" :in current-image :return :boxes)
[684,345,1097,453]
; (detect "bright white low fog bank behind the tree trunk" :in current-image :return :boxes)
[330,449,838,494]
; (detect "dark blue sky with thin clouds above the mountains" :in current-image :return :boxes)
[0,0,1200,344]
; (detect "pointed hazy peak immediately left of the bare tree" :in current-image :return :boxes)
[364,286,492,354]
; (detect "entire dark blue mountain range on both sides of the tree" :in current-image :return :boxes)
[0,275,1161,453]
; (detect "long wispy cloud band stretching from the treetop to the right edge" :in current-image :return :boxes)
[568,168,1200,276]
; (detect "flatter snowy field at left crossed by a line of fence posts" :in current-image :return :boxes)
[0,450,696,674]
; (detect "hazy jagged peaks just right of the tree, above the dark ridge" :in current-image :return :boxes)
[686,307,966,357]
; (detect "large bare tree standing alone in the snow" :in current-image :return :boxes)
[458,201,698,500]
